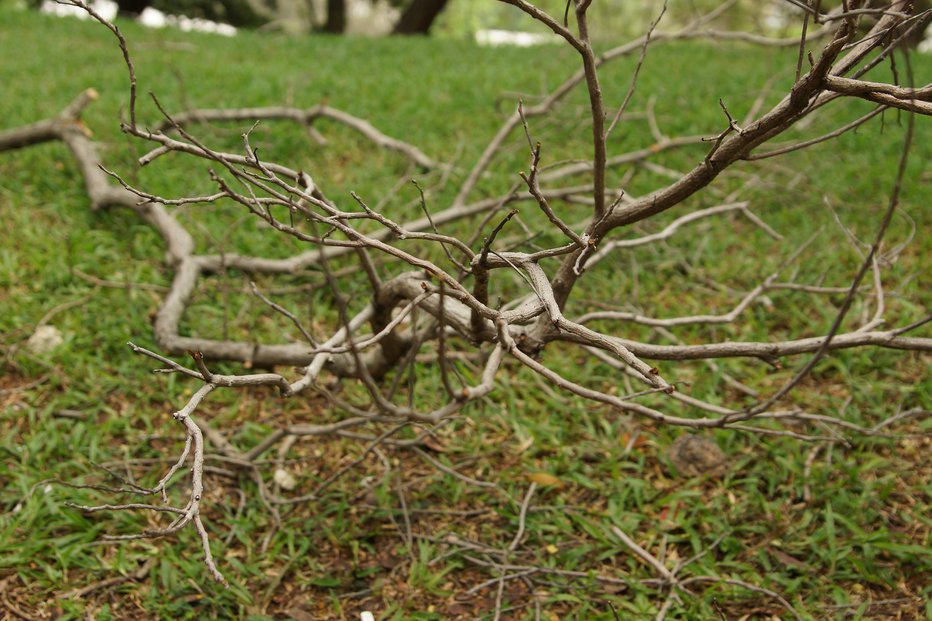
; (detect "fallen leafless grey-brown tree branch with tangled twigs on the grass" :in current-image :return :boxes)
[0,0,932,588]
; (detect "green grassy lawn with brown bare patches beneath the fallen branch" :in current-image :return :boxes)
[0,3,932,620]
